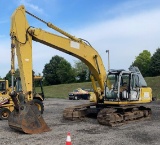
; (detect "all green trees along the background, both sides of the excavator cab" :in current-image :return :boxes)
[1,48,160,86]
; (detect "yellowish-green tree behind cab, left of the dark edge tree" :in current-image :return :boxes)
[132,50,151,77]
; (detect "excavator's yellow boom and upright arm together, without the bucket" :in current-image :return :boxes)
[10,6,106,100]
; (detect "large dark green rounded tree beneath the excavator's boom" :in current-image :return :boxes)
[43,55,75,85]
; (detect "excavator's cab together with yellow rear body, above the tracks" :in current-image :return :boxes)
[104,67,152,102]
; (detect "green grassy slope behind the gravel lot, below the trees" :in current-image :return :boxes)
[37,76,160,99]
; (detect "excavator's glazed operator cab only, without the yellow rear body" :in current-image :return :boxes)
[105,70,135,101]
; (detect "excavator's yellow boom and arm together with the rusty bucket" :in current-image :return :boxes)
[8,6,106,133]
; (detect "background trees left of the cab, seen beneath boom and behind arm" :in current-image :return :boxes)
[5,55,90,86]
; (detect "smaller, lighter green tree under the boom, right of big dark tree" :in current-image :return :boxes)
[74,60,89,82]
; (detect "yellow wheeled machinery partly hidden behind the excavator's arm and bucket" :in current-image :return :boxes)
[0,76,44,120]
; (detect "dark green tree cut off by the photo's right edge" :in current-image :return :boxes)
[149,48,160,76]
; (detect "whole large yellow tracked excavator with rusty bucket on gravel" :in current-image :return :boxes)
[8,5,152,134]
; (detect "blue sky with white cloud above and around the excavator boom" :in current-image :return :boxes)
[0,0,160,77]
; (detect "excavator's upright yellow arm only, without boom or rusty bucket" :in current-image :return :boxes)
[10,7,33,101]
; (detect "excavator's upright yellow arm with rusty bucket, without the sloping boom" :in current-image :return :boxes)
[8,6,51,134]
